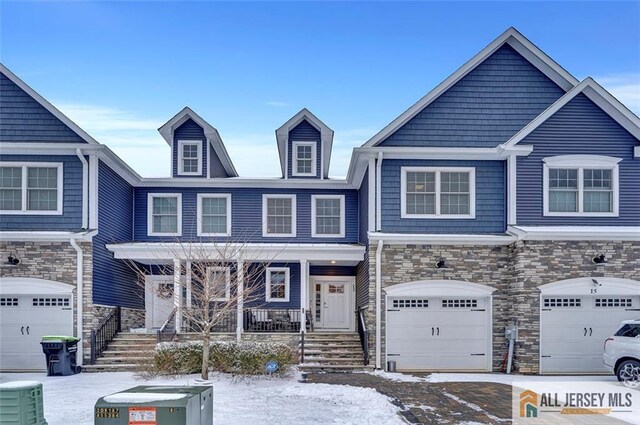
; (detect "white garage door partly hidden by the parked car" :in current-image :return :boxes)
[540,278,640,373]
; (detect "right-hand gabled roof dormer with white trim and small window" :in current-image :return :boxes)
[276,108,333,179]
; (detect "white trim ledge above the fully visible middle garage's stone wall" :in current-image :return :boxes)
[369,232,517,246]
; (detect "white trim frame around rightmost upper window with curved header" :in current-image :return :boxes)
[542,155,622,217]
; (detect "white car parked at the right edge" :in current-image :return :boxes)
[603,320,640,386]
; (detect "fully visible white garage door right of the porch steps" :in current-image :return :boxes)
[387,296,491,371]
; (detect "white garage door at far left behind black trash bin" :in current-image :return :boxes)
[0,281,73,371]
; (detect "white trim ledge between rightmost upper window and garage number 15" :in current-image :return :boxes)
[507,226,640,241]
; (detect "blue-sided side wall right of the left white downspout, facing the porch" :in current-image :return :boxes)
[93,161,144,308]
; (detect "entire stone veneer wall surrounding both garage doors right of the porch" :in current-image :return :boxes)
[367,241,640,374]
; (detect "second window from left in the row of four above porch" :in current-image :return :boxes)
[198,193,231,236]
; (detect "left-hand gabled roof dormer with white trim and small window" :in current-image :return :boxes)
[158,107,238,178]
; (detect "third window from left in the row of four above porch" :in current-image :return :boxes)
[262,195,296,237]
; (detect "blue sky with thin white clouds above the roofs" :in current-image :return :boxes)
[0,1,640,177]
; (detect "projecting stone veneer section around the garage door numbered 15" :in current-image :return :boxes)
[510,241,640,373]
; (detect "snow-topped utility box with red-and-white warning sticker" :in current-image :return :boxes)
[94,385,213,425]
